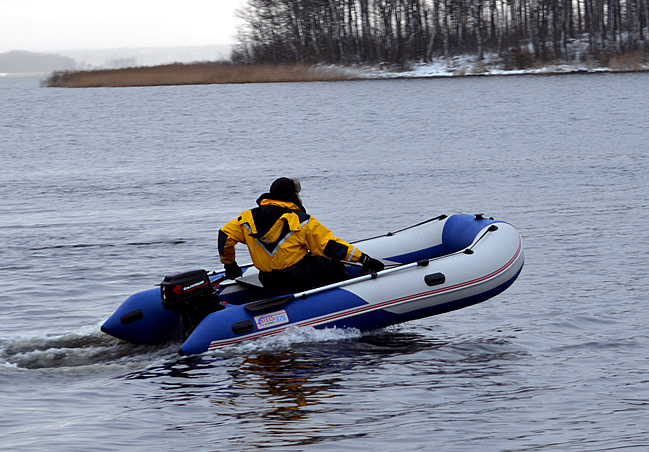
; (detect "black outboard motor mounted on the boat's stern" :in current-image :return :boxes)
[160,270,223,335]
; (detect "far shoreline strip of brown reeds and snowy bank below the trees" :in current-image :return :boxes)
[41,61,649,88]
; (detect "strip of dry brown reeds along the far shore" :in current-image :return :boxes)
[43,62,356,88]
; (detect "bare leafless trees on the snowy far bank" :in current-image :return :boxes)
[232,0,649,67]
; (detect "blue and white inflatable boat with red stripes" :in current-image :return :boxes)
[101,214,524,355]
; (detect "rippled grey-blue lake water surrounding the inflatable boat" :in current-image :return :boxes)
[0,73,649,451]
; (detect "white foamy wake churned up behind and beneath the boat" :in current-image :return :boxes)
[0,326,438,378]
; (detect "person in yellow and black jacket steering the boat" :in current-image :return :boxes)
[218,177,384,292]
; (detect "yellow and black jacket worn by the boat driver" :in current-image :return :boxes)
[218,198,363,272]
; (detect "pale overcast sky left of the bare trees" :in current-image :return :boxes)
[0,0,245,53]
